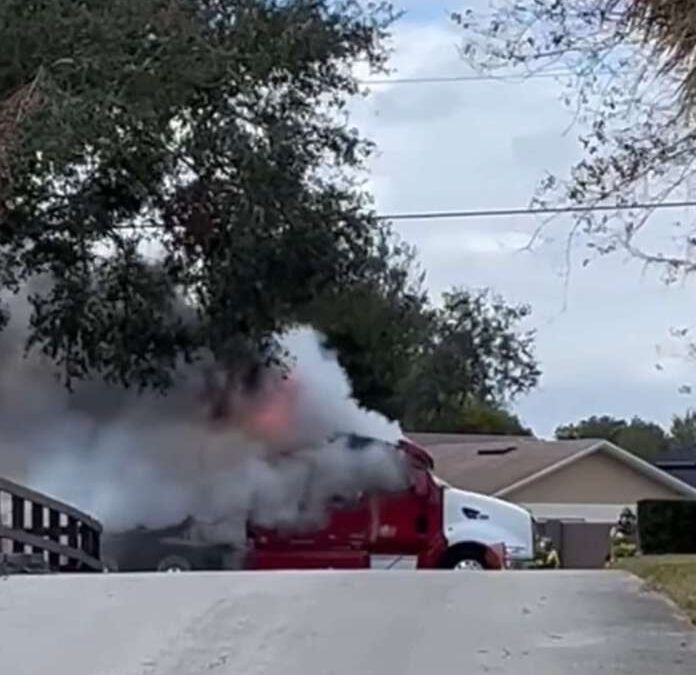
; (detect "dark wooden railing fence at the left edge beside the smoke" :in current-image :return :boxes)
[0,478,103,572]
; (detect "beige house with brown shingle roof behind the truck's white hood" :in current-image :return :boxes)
[408,433,696,568]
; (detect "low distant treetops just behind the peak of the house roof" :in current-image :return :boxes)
[556,415,669,459]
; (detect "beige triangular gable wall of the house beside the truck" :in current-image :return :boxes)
[505,450,682,504]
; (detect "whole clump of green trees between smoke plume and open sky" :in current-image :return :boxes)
[300,268,539,435]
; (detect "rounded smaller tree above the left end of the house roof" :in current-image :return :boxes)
[403,289,540,429]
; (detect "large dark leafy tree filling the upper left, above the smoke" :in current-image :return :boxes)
[0,0,393,389]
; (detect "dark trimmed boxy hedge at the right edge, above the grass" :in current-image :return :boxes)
[638,499,696,555]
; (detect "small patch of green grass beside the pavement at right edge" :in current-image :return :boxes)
[614,555,696,624]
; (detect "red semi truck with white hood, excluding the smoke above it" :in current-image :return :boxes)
[103,440,534,571]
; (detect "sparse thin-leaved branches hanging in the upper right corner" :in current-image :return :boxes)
[454,0,696,281]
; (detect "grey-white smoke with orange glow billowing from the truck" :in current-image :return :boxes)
[0,282,406,543]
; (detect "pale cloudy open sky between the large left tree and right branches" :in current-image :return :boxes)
[353,0,696,436]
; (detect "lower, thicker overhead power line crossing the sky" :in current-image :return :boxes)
[378,200,696,220]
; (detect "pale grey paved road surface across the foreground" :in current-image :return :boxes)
[0,572,696,675]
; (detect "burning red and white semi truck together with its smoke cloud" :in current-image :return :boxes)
[0,320,533,571]
